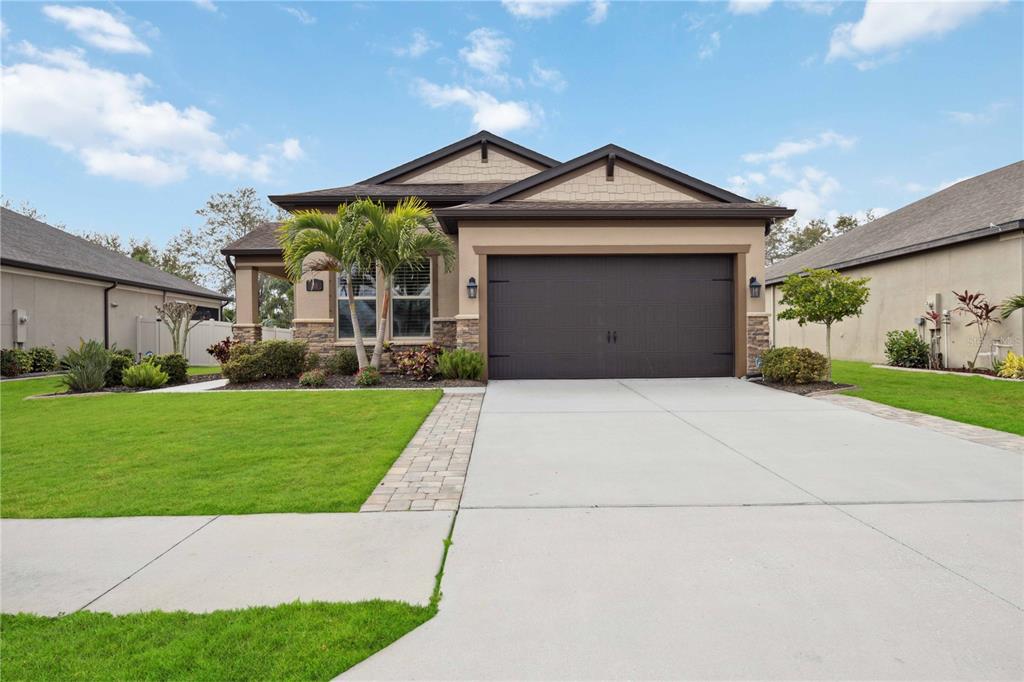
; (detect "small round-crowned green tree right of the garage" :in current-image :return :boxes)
[778,269,870,381]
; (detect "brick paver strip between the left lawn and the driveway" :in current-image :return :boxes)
[359,391,483,512]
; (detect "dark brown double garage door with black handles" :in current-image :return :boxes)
[487,255,735,379]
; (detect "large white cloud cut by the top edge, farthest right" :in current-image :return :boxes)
[827,0,1005,62]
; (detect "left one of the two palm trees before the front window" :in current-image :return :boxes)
[278,204,373,369]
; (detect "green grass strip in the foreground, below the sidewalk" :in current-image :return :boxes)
[0,601,436,682]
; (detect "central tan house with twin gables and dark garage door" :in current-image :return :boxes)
[223,131,794,379]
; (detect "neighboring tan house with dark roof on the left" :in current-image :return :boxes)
[0,209,230,354]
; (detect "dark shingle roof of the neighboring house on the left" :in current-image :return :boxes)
[0,208,230,301]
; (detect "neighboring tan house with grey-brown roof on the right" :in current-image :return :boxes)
[767,161,1024,368]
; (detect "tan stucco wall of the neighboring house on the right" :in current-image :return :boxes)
[766,232,1024,368]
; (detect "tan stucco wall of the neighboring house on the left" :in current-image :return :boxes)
[0,267,220,354]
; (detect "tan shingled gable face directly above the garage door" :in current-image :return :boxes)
[506,161,717,203]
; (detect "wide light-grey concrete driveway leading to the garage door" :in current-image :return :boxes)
[346,379,1024,679]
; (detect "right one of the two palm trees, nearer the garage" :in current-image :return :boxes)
[348,197,456,369]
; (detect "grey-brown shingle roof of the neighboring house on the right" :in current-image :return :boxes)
[766,161,1024,284]
